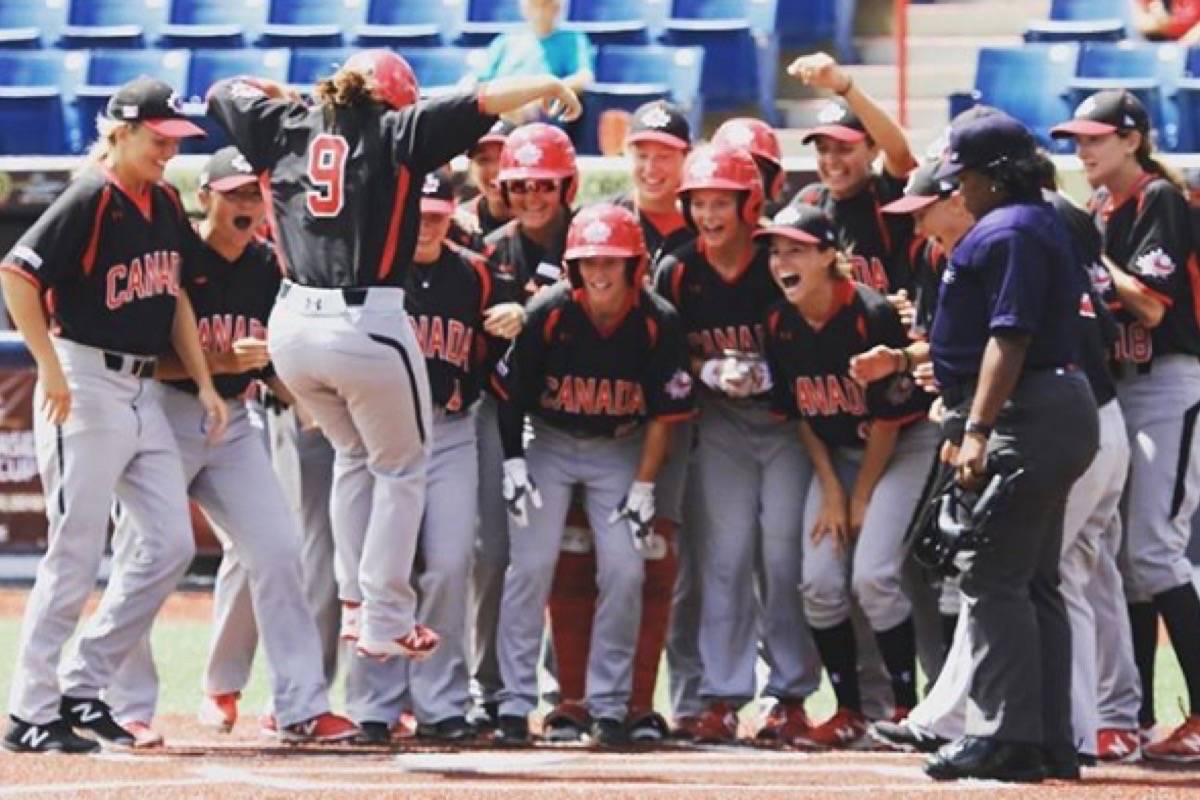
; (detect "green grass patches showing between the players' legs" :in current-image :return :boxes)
[0,619,1187,726]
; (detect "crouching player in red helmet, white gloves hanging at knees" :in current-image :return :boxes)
[493,204,694,745]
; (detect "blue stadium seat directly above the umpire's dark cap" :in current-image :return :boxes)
[950,42,1079,151]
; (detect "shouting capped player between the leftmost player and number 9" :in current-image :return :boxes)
[106,148,358,741]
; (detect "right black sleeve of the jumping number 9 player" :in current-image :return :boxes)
[383,90,497,174]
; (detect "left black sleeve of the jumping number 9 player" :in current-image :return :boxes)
[208,76,307,172]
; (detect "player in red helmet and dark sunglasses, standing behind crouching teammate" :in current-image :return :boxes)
[470,122,578,728]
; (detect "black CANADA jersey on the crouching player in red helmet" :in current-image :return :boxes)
[492,283,695,452]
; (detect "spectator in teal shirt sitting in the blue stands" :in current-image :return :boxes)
[476,0,593,124]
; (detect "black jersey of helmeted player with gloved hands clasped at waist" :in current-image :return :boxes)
[654,240,782,376]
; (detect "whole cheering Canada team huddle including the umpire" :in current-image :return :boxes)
[0,50,1200,781]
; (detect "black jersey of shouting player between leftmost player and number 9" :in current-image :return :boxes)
[167,233,281,398]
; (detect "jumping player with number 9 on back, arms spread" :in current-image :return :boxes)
[209,50,580,671]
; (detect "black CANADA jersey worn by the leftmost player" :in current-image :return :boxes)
[2,167,188,355]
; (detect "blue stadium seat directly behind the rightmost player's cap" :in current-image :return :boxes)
[1072,41,1187,150]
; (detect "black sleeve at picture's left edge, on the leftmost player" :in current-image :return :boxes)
[4,176,100,289]
